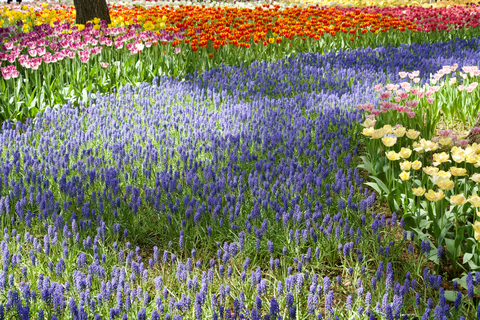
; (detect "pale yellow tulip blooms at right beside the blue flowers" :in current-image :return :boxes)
[362,119,480,241]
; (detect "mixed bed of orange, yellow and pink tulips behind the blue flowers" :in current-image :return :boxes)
[0,4,479,120]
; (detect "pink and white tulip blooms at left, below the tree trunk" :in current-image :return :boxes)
[0,21,169,79]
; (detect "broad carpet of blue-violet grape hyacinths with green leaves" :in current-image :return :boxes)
[0,39,480,320]
